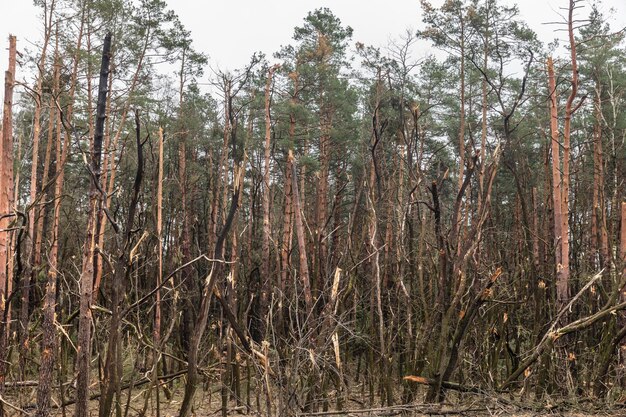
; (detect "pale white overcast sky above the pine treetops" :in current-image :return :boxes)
[0,0,626,79]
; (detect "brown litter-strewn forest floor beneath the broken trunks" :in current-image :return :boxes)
[4,384,626,417]
